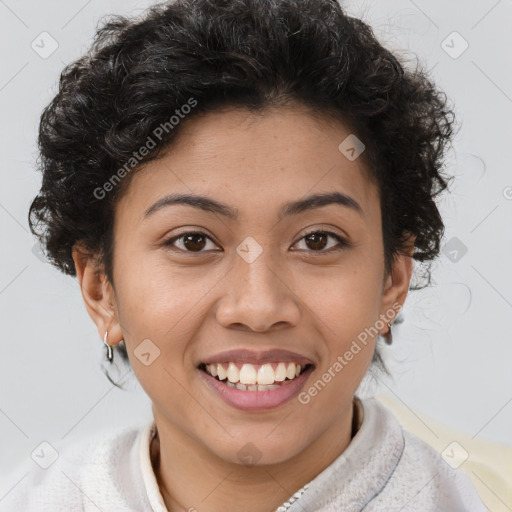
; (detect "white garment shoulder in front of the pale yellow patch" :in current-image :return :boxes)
[363,400,488,512]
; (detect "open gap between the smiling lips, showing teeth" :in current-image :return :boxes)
[198,361,314,391]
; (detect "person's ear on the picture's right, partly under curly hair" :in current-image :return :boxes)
[380,234,416,332]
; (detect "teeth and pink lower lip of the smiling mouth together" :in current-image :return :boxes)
[198,361,315,411]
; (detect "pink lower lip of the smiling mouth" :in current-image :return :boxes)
[198,366,314,411]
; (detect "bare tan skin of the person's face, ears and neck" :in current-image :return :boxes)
[73,106,413,512]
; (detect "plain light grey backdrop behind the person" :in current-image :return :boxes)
[0,0,512,497]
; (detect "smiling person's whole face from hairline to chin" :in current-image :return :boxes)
[75,108,410,464]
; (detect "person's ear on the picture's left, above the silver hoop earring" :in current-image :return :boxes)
[72,242,123,345]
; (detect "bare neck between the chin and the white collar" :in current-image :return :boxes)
[151,400,361,512]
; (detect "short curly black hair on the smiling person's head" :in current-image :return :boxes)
[29,0,455,376]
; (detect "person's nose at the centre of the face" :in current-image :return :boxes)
[216,251,302,332]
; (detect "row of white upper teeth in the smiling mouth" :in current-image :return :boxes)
[205,362,303,384]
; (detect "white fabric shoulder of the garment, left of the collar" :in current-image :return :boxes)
[0,425,150,512]
